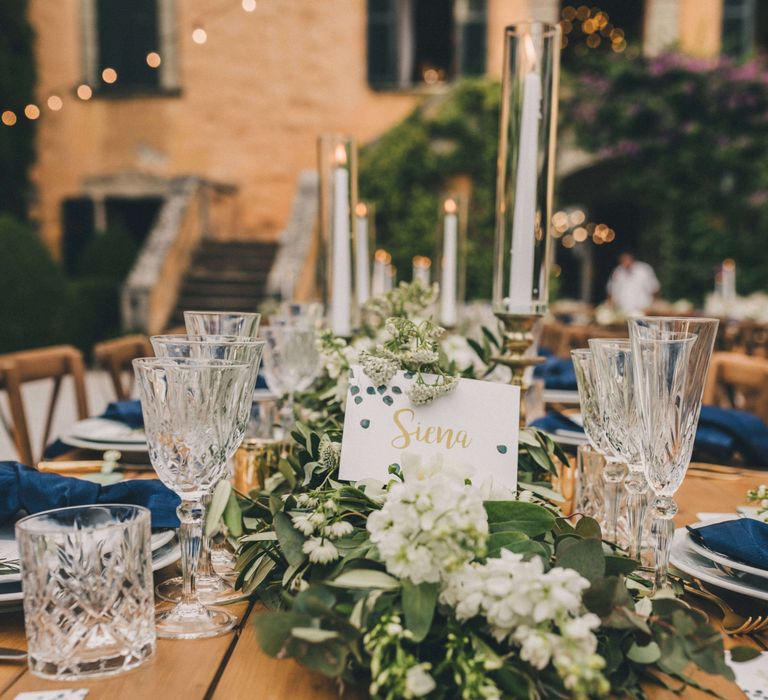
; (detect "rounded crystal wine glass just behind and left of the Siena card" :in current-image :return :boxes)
[264,323,320,434]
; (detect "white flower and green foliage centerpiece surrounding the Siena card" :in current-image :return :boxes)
[211,285,747,700]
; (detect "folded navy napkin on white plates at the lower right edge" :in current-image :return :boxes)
[688,518,768,571]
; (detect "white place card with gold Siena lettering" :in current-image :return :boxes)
[339,365,520,490]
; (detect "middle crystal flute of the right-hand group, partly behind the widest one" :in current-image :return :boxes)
[589,338,649,560]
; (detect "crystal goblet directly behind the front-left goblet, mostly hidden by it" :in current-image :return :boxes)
[150,335,265,604]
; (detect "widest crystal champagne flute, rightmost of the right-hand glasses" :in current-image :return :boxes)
[629,318,718,590]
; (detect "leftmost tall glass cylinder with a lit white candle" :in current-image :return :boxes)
[318,134,357,337]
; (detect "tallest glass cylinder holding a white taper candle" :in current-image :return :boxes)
[493,22,561,315]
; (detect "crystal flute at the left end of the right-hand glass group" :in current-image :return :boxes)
[571,349,626,542]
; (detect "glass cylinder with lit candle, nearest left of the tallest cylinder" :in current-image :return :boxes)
[436,194,467,328]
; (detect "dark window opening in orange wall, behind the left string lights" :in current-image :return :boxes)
[96,0,160,91]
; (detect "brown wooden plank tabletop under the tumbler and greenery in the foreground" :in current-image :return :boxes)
[0,462,768,700]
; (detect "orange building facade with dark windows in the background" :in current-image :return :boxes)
[30,0,736,256]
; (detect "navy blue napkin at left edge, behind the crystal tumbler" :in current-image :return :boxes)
[0,462,179,528]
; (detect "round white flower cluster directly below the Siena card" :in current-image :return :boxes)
[367,473,488,583]
